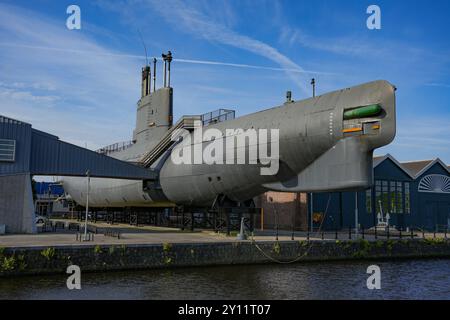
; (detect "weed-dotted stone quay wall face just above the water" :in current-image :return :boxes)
[0,239,450,276]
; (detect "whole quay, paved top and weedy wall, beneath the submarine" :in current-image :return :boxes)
[0,220,450,277]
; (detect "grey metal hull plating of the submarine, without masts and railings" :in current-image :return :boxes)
[63,80,396,207]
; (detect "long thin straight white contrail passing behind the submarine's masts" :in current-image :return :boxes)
[0,43,337,75]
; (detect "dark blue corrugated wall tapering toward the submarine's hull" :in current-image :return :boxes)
[0,116,155,179]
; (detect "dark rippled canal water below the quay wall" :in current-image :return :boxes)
[0,259,450,299]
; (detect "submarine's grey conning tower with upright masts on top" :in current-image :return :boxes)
[133,51,173,148]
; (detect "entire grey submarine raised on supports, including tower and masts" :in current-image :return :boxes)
[62,51,396,208]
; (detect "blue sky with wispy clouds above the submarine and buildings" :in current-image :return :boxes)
[0,0,450,163]
